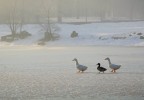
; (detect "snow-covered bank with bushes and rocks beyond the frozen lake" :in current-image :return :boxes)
[0,21,144,46]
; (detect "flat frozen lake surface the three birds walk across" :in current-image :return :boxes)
[0,46,144,100]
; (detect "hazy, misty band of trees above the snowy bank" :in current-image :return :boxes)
[0,0,144,23]
